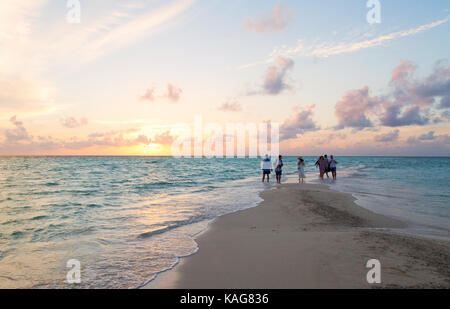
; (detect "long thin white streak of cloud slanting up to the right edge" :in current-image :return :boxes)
[238,15,450,69]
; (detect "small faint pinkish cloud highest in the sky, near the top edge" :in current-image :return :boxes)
[245,4,294,33]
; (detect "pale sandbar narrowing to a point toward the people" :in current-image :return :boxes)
[145,184,450,289]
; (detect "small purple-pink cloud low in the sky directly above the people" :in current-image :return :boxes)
[280,105,319,140]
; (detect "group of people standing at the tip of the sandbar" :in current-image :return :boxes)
[261,155,338,183]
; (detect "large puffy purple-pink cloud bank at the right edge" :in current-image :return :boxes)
[335,61,450,130]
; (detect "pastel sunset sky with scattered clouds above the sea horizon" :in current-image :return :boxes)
[0,0,450,156]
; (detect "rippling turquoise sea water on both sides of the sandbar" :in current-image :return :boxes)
[0,157,450,288]
